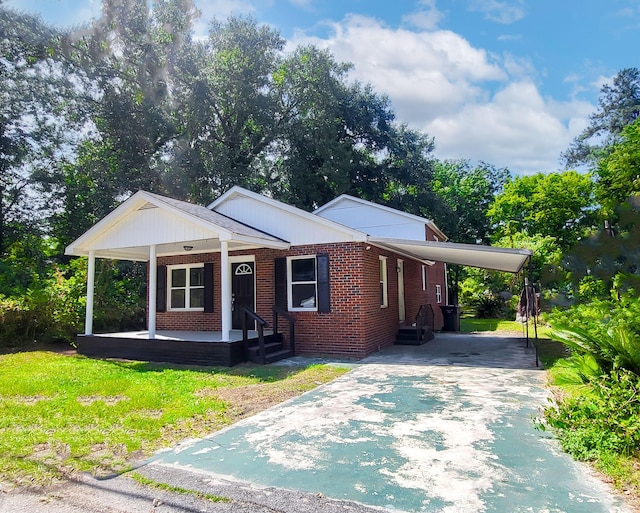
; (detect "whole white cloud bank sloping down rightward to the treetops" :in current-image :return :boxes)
[291,16,593,173]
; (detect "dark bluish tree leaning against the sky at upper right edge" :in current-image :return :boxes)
[562,68,640,168]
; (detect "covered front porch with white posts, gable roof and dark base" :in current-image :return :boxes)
[66,191,290,366]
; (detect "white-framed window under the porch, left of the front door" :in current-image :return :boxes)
[167,264,204,310]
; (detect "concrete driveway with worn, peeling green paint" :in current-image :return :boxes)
[148,334,628,513]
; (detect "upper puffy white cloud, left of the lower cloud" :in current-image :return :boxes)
[293,16,506,122]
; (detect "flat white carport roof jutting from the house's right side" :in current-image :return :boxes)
[368,237,533,273]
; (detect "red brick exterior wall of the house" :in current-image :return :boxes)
[156,243,444,358]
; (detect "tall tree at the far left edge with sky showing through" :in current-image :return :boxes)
[0,3,69,255]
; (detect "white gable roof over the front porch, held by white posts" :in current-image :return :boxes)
[65,191,289,261]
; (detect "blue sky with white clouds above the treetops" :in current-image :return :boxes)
[7,0,640,174]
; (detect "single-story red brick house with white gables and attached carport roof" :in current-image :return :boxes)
[66,187,531,365]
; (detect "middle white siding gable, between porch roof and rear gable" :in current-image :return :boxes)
[212,192,365,246]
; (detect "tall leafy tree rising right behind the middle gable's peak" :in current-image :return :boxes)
[183,17,292,200]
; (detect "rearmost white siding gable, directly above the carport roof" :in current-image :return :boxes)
[316,197,426,240]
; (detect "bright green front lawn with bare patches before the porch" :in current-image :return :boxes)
[0,351,347,485]
